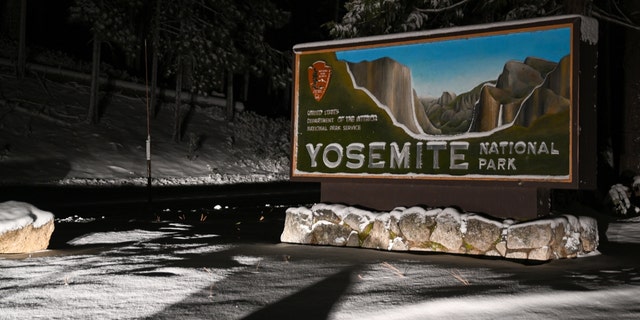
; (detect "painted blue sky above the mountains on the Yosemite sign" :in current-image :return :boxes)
[336,27,571,97]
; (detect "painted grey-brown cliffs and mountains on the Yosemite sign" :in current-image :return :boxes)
[347,55,571,135]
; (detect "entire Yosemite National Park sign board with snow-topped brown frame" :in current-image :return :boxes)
[291,16,597,188]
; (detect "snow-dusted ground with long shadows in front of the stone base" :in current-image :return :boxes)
[0,208,640,319]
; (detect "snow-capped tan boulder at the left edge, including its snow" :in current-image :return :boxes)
[0,201,54,253]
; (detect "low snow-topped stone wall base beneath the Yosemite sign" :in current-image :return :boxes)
[280,204,599,261]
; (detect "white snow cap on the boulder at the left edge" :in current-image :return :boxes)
[0,201,53,234]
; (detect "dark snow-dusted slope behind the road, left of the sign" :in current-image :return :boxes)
[0,68,290,185]
